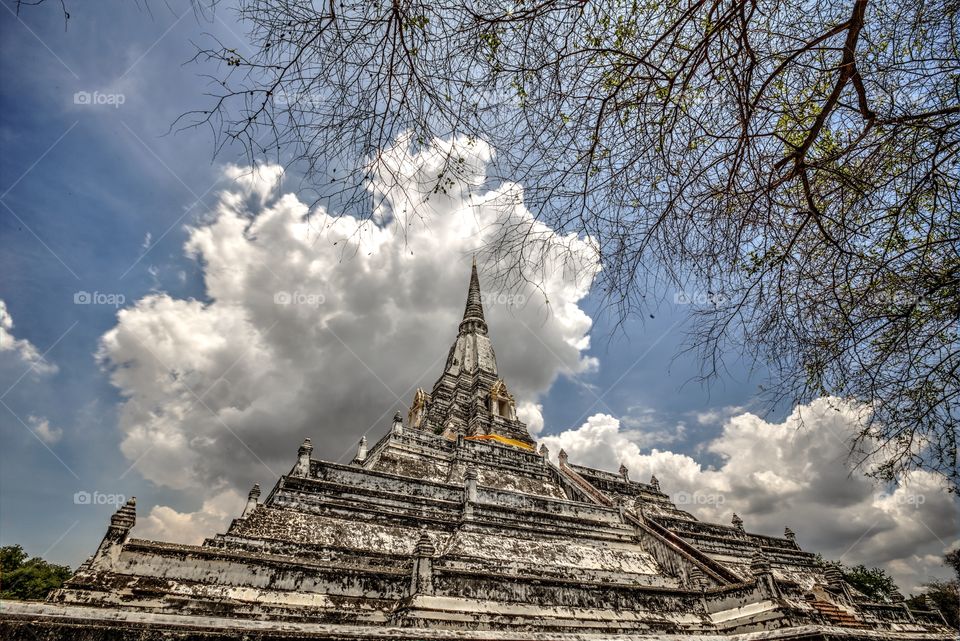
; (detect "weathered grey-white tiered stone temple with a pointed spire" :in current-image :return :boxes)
[0,264,956,641]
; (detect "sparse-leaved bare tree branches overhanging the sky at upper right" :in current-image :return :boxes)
[183,0,960,490]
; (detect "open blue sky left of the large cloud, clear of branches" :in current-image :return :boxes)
[0,2,251,565]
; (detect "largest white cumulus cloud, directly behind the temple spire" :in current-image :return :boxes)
[98,142,598,535]
